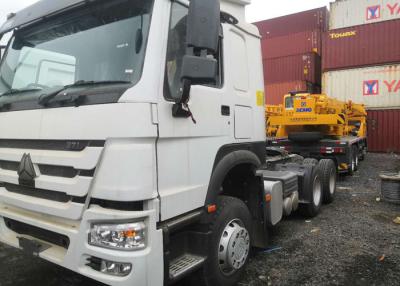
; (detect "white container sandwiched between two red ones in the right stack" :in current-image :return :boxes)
[322,64,400,109]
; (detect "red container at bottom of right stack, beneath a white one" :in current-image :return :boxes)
[368,109,400,153]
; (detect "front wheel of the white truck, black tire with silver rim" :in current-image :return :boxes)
[201,196,251,286]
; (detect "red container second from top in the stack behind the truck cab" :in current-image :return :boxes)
[261,30,322,59]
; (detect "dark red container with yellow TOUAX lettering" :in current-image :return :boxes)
[322,20,400,71]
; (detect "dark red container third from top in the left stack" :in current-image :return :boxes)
[263,53,321,84]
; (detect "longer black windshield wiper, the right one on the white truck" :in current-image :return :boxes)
[38,80,131,106]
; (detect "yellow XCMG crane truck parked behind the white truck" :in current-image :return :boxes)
[266,92,367,175]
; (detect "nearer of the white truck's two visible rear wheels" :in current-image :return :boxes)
[300,168,323,218]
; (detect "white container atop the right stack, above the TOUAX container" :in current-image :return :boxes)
[329,0,400,30]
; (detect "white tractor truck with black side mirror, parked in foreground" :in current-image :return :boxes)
[0,0,336,286]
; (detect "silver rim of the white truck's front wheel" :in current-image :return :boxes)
[218,219,250,275]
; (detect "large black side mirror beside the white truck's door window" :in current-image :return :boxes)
[181,0,221,103]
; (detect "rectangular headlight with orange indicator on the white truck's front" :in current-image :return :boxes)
[89,222,146,250]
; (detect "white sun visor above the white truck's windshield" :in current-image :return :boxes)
[0,0,92,34]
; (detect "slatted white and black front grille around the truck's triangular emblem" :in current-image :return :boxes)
[0,140,105,219]
